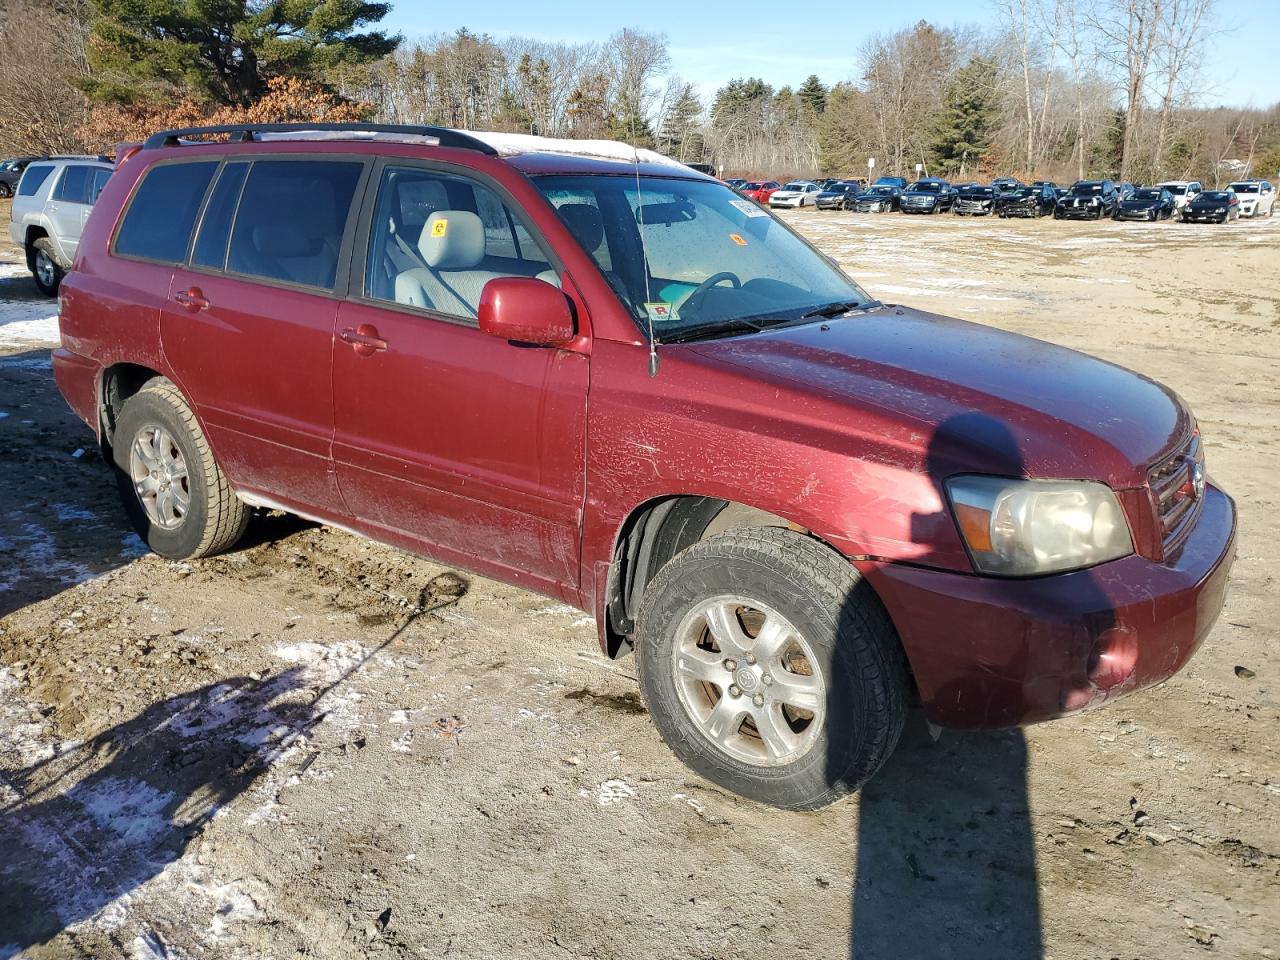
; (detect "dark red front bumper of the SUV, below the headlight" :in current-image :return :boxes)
[856,484,1235,727]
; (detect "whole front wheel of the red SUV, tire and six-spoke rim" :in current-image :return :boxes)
[636,527,908,810]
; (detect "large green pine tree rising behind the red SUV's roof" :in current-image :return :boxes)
[83,0,401,106]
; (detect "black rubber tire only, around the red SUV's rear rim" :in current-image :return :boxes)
[113,378,250,559]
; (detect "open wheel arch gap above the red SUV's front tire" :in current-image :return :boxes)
[599,494,842,658]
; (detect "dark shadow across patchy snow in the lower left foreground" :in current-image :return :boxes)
[0,669,324,957]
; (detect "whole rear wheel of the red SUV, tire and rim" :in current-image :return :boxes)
[113,379,250,559]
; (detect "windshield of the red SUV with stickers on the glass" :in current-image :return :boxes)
[535,177,874,342]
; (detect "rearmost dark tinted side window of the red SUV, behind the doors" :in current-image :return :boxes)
[115,160,218,264]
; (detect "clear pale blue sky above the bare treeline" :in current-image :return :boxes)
[387,0,1280,106]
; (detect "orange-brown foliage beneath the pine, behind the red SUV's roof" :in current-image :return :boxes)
[83,77,369,152]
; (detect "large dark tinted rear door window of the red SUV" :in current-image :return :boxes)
[227,160,364,289]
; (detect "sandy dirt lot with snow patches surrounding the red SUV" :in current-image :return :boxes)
[0,195,1280,960]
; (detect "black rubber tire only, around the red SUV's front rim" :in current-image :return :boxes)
[636,527,908,810]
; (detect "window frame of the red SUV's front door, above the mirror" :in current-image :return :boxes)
[343,156,564,330]
